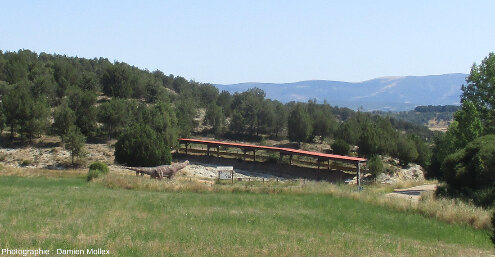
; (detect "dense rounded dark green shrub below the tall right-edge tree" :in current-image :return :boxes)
[438,135,495,206]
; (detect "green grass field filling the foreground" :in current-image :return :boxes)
[0,176,495,256]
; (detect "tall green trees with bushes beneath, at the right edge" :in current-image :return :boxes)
[429,53,495,206]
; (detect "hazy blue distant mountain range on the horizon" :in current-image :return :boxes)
[215,73,467,111]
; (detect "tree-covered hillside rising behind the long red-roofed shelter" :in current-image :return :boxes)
[0,50,433,165]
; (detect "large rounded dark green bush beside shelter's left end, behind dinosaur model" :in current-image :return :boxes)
[115,124,172,167]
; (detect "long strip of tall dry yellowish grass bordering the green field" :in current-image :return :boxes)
[96,174,491,229]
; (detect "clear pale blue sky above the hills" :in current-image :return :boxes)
[0,0,495,83]
